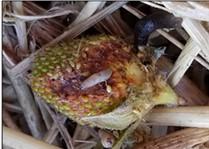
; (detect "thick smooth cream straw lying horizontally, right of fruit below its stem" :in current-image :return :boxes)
[145,106,209,128]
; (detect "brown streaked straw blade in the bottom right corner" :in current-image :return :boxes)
[134,128,209,149]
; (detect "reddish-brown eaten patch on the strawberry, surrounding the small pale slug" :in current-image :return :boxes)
[43,37,135,116]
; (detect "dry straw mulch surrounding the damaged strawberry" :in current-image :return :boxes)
[2,1,209,149]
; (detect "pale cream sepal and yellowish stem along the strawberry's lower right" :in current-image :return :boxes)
[81,83,177,130]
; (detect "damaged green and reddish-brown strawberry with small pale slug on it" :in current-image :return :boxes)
[31,35,178,130]
